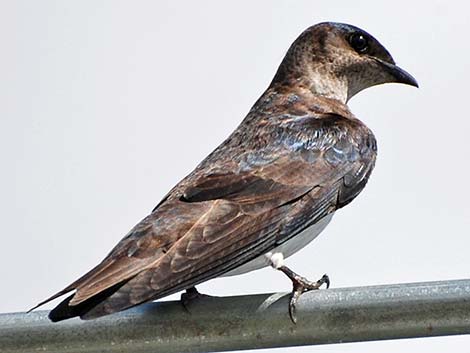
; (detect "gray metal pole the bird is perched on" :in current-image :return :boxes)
[0,280,470,353]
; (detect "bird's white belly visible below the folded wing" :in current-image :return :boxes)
[222,213,333,277]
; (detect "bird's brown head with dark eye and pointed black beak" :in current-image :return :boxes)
[273,22,418,102]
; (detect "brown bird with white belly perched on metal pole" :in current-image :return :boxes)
[31,22,418,323]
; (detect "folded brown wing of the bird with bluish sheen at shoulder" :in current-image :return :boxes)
[35,113,375,320]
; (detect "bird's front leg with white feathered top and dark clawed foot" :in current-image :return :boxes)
[266,253,330,324]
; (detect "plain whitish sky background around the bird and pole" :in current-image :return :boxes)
[0,0,470,352]
